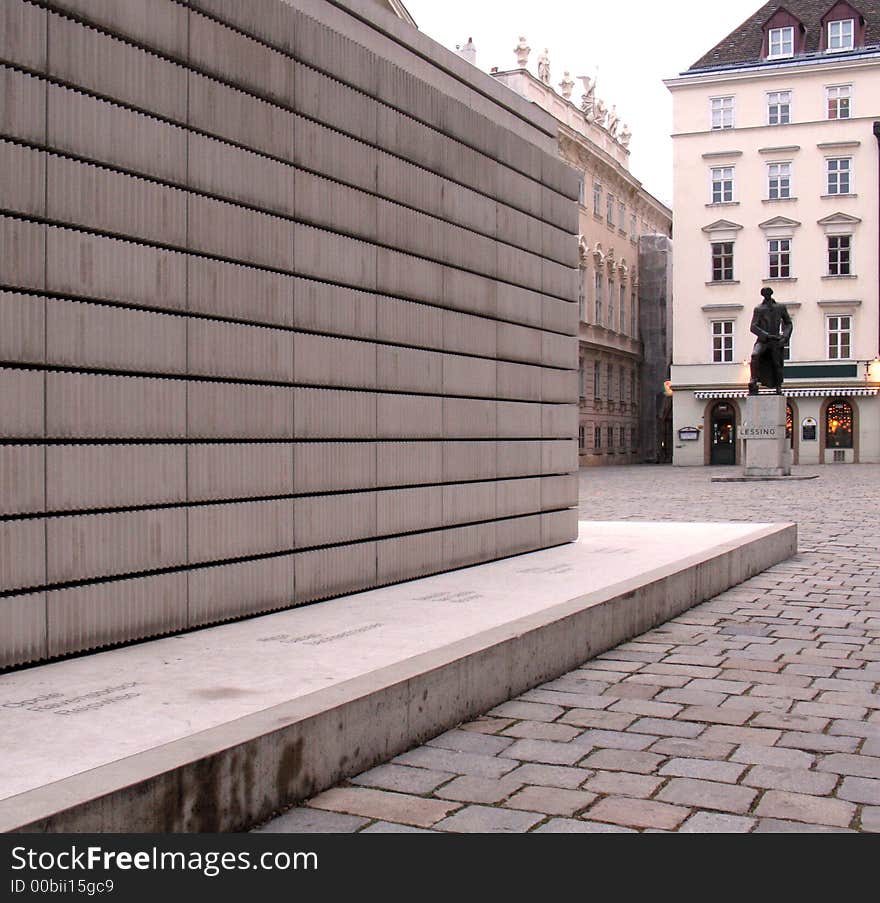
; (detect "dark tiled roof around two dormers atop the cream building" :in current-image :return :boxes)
[687,0,880,72]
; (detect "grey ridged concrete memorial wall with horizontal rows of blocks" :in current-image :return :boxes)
[0,0,577,666]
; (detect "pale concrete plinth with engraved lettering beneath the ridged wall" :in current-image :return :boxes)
[0,522,797,832]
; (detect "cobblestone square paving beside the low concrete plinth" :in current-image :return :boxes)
[253,465,880,833]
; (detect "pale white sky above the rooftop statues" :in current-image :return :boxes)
[404,0,763,204]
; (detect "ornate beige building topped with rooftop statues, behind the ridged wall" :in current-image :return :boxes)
[492,55,672,467]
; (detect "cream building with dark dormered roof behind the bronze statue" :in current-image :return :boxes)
[666,0,880,465]
